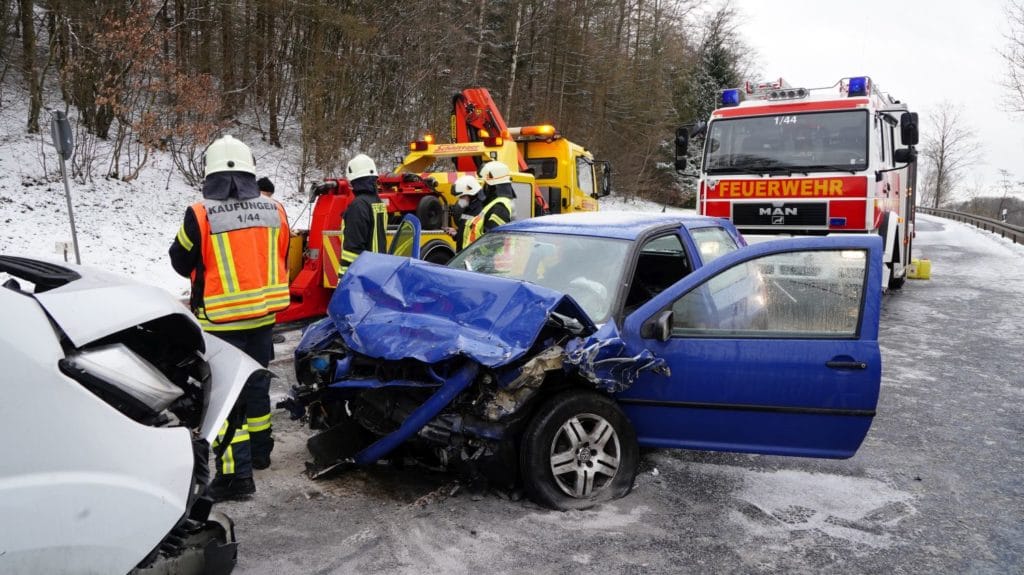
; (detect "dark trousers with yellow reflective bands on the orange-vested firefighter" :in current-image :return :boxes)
[214,324,273,477]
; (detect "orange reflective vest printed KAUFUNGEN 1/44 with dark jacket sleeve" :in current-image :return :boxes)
[171,196,289,331]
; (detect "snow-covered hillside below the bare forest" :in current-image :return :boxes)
[0,90,688,296]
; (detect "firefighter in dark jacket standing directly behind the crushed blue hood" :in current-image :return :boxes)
[338,153,387,277]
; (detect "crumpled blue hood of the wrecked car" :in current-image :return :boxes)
[328,253,596,367]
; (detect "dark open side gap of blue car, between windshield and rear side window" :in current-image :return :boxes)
[625,232,693,315]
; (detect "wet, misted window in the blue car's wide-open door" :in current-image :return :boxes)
[672,250,867,339]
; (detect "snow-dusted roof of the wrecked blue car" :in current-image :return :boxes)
[499,212,732,239]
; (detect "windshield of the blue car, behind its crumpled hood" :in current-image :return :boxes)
[449,231,632,323]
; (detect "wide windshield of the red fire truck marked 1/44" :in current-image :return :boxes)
[703,109,869,174]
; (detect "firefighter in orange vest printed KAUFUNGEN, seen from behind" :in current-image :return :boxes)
[169,136,289,500]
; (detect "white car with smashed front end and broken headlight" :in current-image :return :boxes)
[0,257,261,573]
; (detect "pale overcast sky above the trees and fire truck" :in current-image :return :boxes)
[733,0,1024,192]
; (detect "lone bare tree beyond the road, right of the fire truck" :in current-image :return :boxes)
[921,101,980,208]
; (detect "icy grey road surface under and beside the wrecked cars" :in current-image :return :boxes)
[223,216,1024,575]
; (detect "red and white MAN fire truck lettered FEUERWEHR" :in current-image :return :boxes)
[676,77,918,290]
